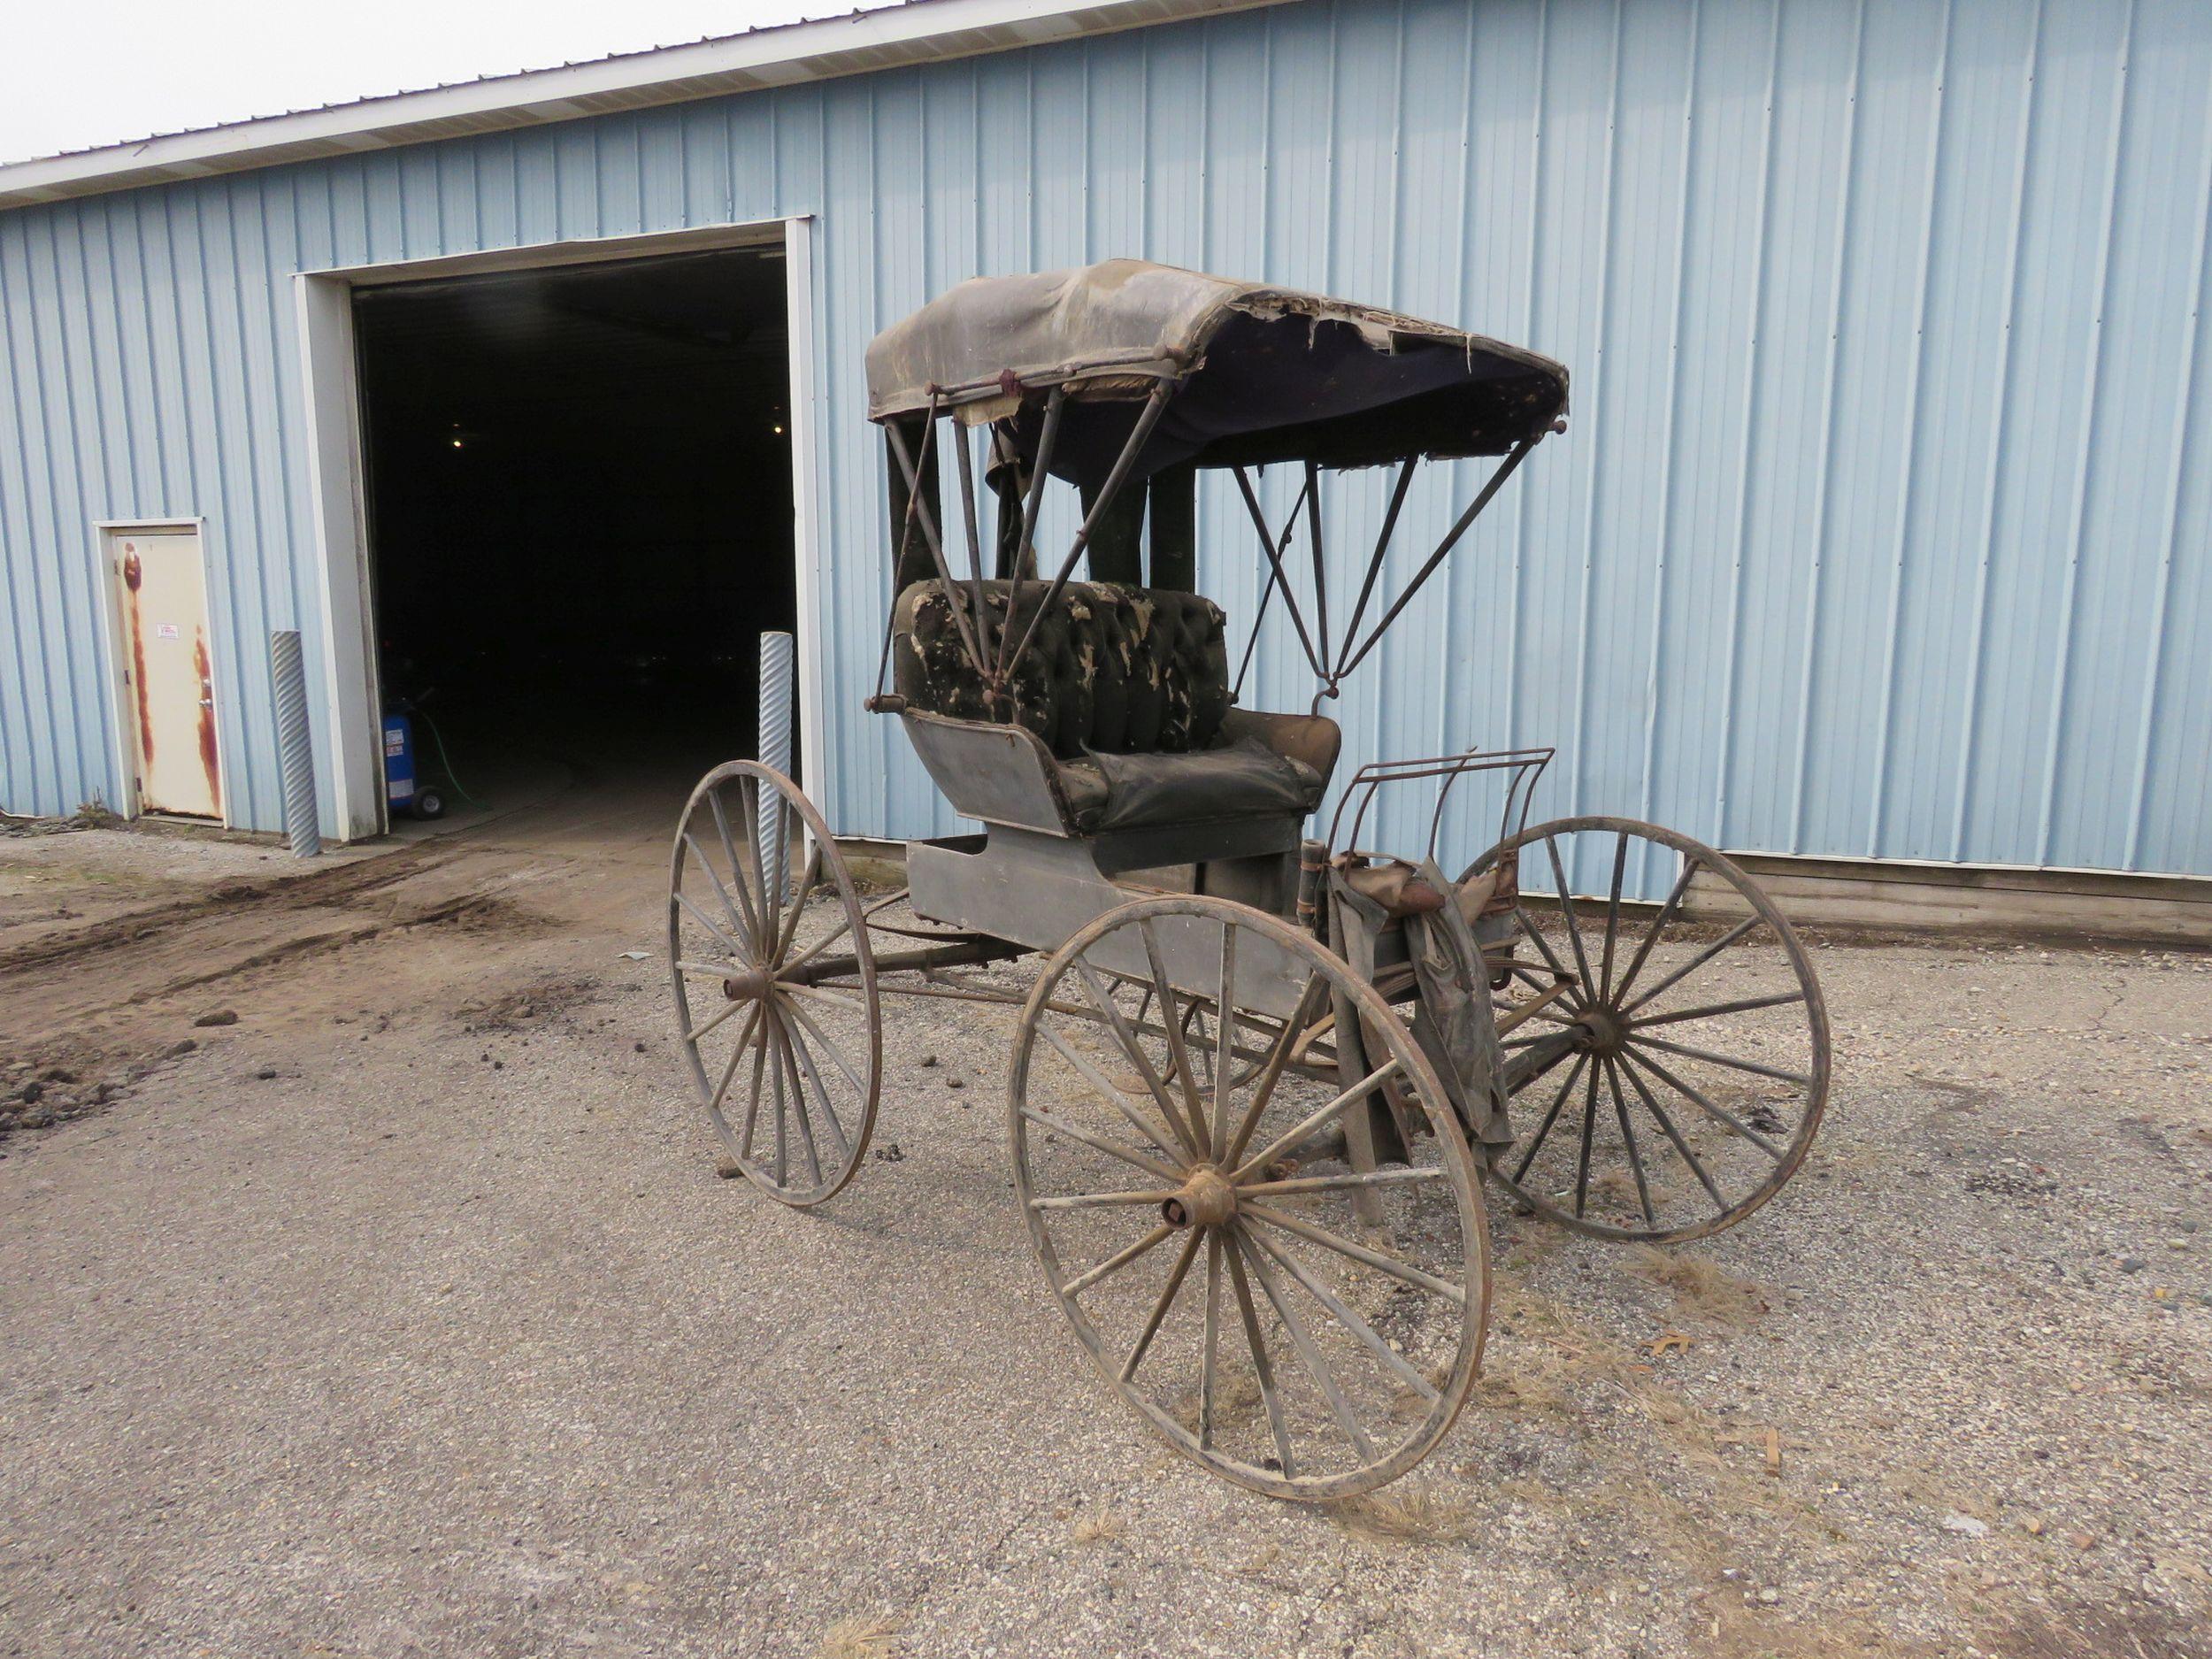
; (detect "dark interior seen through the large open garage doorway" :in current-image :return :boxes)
[354,248,795,821]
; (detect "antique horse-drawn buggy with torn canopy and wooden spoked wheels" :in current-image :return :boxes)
[668,261,1827,1498]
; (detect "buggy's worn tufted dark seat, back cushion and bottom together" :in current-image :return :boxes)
[892,582,1339,834]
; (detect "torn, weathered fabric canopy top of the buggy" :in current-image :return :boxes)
[867,259,1566,489]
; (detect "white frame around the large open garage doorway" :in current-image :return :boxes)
[289,217,823,841]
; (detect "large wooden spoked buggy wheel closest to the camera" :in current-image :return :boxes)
[1007,896,1489,1500]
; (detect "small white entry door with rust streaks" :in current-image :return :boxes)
[109,526,224,818]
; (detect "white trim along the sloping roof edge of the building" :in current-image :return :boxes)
[0,0,1283,208]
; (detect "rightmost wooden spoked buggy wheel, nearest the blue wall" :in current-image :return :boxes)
[1467,818,1827,1243]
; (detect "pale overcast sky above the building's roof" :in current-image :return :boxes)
[0,0,883,162]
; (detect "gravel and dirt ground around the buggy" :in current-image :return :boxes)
[0,818,2212,1659]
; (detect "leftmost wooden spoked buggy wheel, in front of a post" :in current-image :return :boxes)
[668,761,883,1208]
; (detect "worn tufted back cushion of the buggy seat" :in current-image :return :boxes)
[892,580,1230,759]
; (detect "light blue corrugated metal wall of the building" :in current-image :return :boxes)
[0,0,2212,874]
